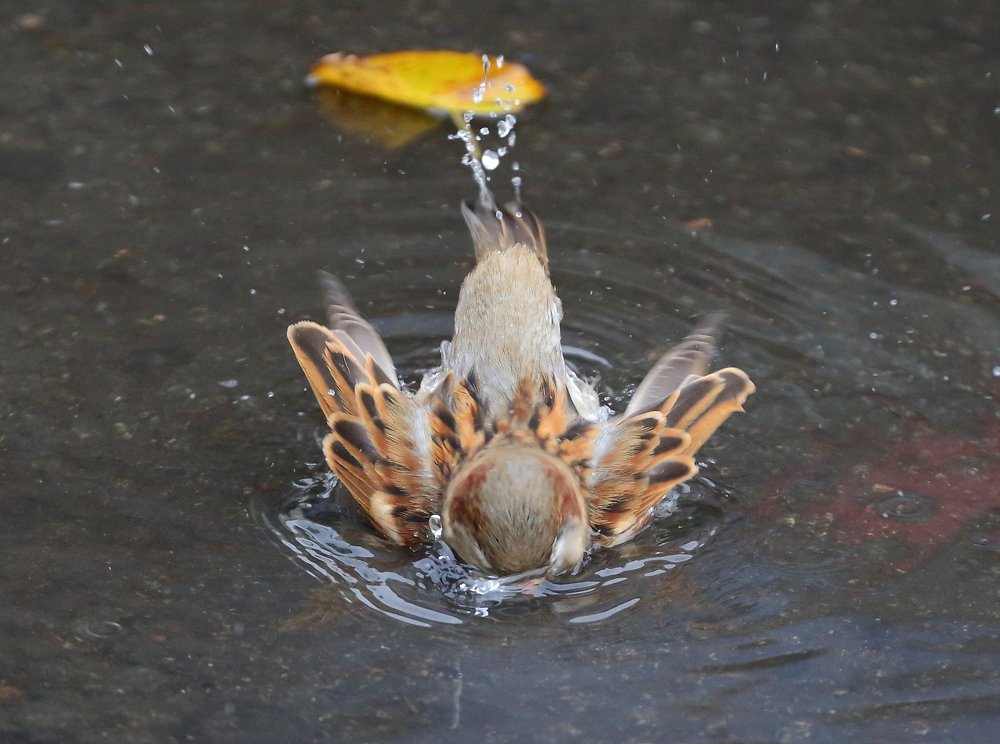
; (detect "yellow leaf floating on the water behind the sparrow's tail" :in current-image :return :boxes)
[306,51,545,116]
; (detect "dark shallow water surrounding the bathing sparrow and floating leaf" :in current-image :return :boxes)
[0,1,1000,743]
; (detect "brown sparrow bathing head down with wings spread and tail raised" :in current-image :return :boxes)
[288,201,754,577]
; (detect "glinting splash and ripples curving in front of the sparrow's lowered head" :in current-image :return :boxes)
[254,466,716,627]
